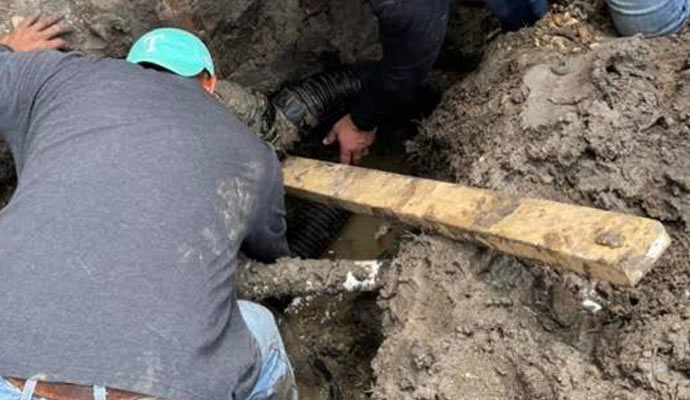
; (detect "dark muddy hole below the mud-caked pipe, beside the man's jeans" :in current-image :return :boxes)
[279,294,383,400]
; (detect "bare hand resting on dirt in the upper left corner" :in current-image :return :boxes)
[0,17,68,51]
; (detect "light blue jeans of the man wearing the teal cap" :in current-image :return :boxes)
[0,300,298,400]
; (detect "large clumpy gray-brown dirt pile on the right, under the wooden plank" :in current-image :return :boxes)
[392,2,690,399]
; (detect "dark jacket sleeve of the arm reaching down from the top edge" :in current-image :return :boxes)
[351,0,450,130]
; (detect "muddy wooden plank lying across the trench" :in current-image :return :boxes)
[283,157,670,286]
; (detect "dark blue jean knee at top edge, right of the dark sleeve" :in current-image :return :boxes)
[486,0,549,31]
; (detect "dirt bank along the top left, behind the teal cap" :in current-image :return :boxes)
[0,0,378,91]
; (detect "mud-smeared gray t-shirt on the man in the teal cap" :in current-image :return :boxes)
[0,52,288,400]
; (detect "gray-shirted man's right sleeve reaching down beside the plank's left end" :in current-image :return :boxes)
[242,154,290,263]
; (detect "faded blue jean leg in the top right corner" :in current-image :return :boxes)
[606,0,688,37]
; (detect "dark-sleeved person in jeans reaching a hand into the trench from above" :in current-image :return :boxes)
[330,0,690,164]
